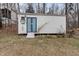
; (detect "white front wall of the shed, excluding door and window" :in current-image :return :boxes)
[18,15,66,34]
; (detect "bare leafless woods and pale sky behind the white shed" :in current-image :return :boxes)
[0,3,79,31]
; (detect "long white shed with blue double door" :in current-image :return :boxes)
[18,14,66,34]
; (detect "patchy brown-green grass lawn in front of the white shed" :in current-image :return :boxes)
[0,33,79,56]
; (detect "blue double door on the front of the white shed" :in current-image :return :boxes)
[27,17,37,33]
